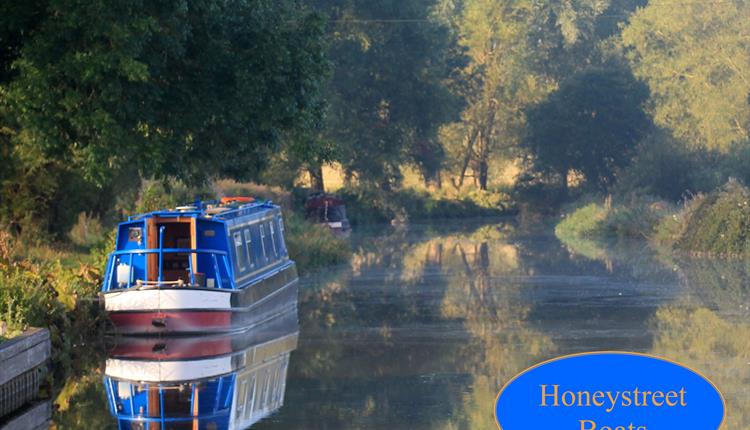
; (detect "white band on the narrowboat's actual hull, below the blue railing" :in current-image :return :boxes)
[104,288,232,312]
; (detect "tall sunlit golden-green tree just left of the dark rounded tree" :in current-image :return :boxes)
[441,0,554,189]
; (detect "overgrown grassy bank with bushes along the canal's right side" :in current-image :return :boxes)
[555,180,750,257]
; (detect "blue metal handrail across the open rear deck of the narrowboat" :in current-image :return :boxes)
[102,249,236,292]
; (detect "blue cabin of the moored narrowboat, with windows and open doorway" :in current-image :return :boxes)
[103,201,290,292]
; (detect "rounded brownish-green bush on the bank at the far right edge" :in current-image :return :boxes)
[675,180,750,256]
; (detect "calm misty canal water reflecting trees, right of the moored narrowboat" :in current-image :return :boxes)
[53,221,750,430]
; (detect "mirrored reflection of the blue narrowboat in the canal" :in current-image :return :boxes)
[104,312,298,430]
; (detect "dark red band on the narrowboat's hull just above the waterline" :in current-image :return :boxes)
[109,311,232,334]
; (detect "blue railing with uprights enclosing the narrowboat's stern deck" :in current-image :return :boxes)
[102,248,235,292]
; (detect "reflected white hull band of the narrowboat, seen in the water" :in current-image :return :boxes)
[104,356,234,382]
